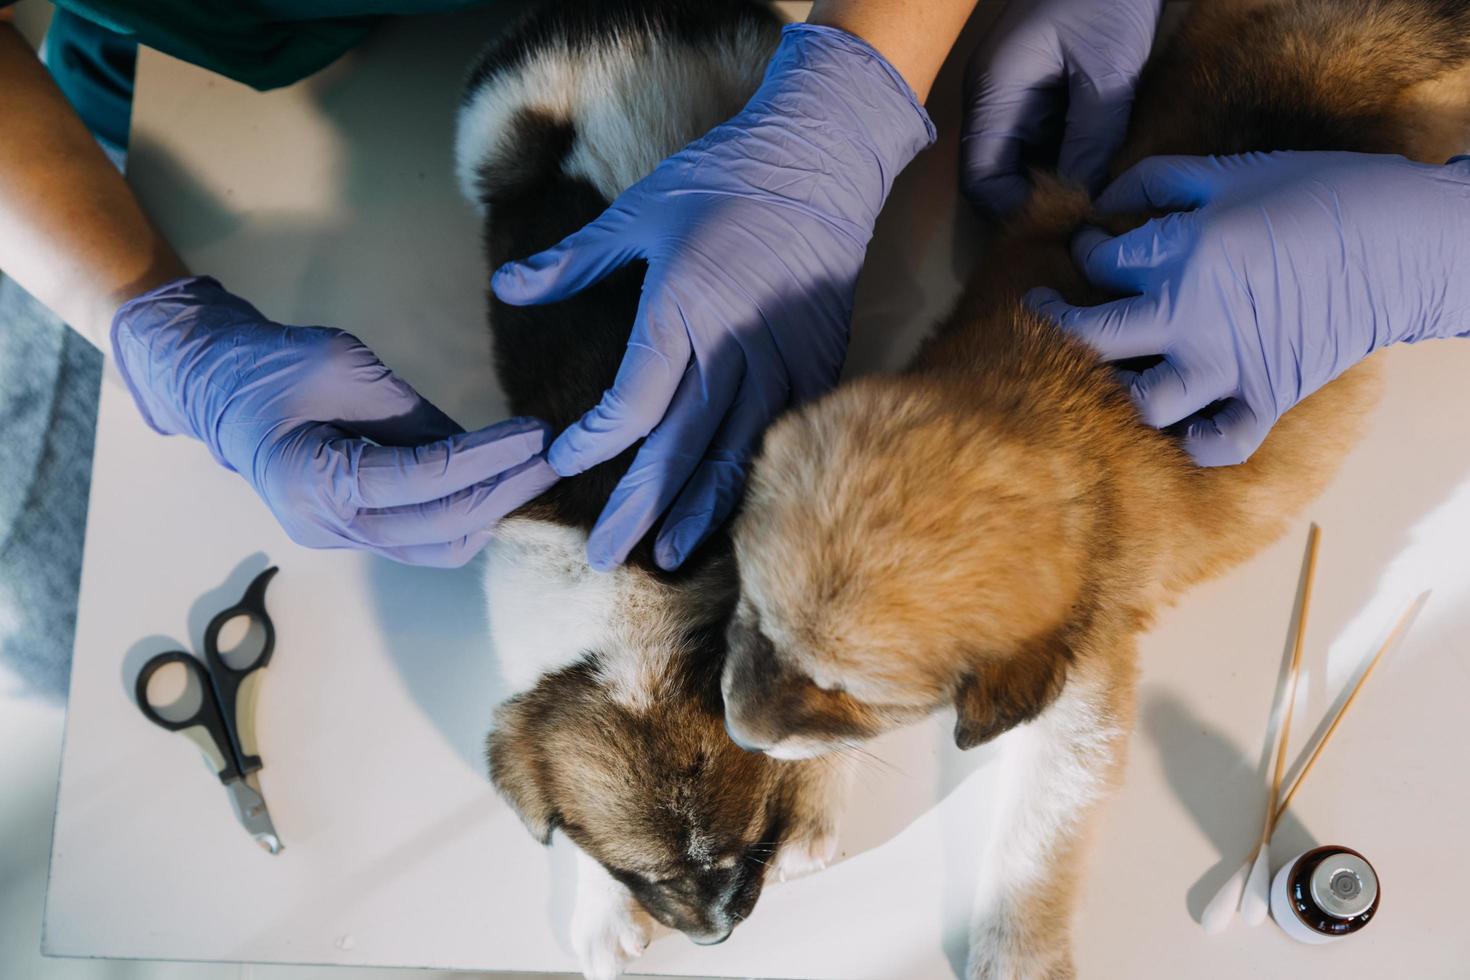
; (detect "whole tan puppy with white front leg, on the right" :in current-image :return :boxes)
[722,0,1470,977]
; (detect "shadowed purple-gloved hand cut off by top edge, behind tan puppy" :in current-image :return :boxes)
[960,0,1163,216]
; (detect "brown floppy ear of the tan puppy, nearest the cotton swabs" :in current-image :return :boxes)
[954,635,1072,749]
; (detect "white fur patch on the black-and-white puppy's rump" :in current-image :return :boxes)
[454,28,775,207]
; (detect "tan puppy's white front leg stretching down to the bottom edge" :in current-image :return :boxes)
[967,657,1133,980]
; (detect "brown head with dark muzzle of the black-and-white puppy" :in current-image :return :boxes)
[488,632,806,943]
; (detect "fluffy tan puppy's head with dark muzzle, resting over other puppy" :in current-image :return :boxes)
[723,376,1088,758]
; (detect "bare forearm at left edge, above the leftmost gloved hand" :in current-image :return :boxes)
[0,22,187,350]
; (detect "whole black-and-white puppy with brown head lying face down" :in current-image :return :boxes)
[456,0,835,977]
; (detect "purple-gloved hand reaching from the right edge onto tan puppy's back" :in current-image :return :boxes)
[1028,153,1470,466]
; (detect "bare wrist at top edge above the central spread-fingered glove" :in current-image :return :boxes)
[807,0,976,101]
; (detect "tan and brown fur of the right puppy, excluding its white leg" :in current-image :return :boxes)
[726,0,1470,758]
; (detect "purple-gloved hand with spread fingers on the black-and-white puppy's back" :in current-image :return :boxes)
[492,24,933,570]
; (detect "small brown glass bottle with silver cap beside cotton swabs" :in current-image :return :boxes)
[1272,845,1379,943]
